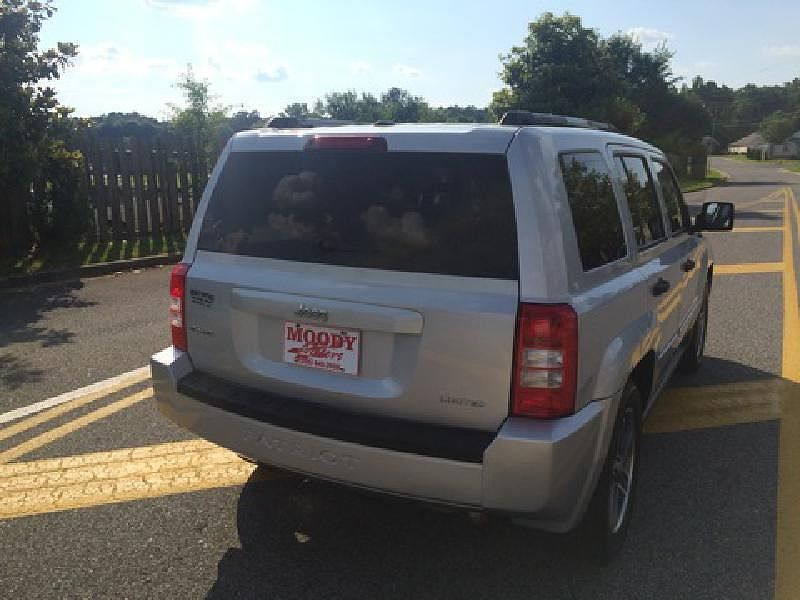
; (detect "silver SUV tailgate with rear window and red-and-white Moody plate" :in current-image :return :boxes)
[186,152,519,430]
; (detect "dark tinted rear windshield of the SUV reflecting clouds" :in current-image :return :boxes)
[198,150,518,279]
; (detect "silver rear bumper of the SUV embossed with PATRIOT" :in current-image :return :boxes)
[150,347,617,531]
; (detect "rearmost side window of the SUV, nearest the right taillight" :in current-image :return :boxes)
[561,152,628,271]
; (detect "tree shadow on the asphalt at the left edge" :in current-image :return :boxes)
[0,279,96,348]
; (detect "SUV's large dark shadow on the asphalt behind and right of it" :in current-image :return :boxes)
[207,358,788,600]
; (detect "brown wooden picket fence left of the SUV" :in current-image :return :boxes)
[80,137,211,241]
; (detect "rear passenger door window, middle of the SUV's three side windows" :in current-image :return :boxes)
[614,156,665,248]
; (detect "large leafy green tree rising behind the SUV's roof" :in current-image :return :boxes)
[490,12,709,151]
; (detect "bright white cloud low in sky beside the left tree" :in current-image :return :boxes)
[74,43,180,77]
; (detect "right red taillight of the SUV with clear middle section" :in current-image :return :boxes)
[511,303,578,419]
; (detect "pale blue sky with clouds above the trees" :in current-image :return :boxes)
[40,0,800,118]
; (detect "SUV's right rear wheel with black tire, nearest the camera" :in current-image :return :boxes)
[581,381,642,563]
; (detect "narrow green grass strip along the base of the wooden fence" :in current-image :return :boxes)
[0,234,186,277]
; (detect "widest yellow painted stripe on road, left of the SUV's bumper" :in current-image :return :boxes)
[0,440,285,519]
